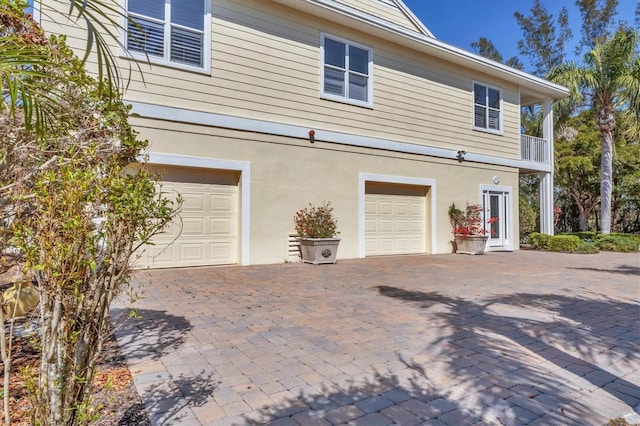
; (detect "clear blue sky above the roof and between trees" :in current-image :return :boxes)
[404,0,638,69]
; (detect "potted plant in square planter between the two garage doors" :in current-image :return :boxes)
[293,201,340,265]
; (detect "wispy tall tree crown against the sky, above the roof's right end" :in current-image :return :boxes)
[514,0,573,77]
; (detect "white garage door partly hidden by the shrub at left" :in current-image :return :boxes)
[140,168,238,268]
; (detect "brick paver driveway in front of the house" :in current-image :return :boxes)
[114,251,640,425]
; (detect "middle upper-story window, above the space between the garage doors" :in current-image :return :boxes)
[322,34,373,107]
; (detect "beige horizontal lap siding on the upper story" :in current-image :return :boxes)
[40,0,520,158]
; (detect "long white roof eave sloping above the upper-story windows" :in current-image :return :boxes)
[272,0,569,99]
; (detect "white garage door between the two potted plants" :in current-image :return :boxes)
[365,183,427,256]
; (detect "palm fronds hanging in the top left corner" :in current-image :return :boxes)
[0,0,131,138]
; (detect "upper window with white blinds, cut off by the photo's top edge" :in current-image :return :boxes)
[126,0,211,69]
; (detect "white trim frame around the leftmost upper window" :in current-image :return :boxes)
[120,0,211,74]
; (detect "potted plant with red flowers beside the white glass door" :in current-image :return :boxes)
[449,203,498,254]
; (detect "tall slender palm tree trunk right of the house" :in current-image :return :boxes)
[598,108,616,234]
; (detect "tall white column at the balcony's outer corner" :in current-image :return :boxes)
[540,99,554,235]
